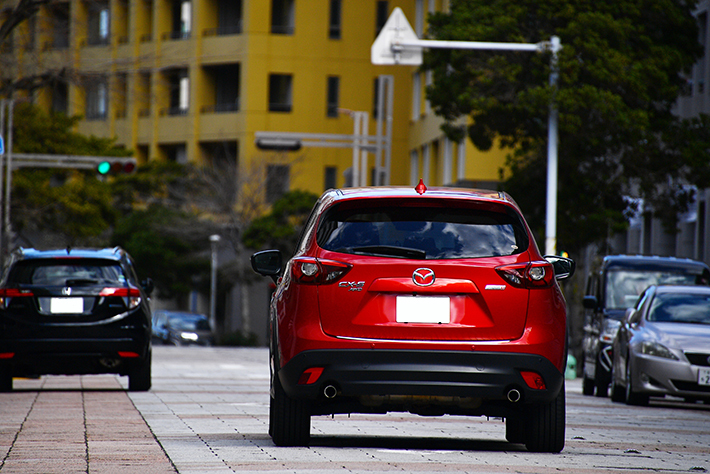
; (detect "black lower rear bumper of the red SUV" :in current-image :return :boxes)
[278,349,564,412]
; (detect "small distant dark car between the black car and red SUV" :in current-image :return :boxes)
[153,309,214,346]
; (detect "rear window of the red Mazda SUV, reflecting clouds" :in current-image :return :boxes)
[316,201,529,259]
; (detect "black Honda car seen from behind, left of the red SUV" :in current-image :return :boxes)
[0,247,153,391]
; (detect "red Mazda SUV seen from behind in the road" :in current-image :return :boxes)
[251,183,574,452]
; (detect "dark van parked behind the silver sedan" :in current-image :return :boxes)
[582,255,710,397]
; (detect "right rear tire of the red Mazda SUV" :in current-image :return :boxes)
[525,383,565,453]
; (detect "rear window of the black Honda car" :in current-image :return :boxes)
[8,259,126,286]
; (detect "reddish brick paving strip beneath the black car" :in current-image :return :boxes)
[0,376,176,474]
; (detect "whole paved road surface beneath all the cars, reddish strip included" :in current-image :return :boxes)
[0,347,710,474]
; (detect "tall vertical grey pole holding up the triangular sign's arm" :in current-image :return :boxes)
[545,36,560,255]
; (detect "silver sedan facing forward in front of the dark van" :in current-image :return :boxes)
[611,286,710,405]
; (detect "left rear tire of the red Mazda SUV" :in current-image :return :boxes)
[269,374,311,446]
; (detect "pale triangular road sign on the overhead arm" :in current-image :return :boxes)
[370,7,422,66]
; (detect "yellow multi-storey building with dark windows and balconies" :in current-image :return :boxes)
[0,0,504,196]
